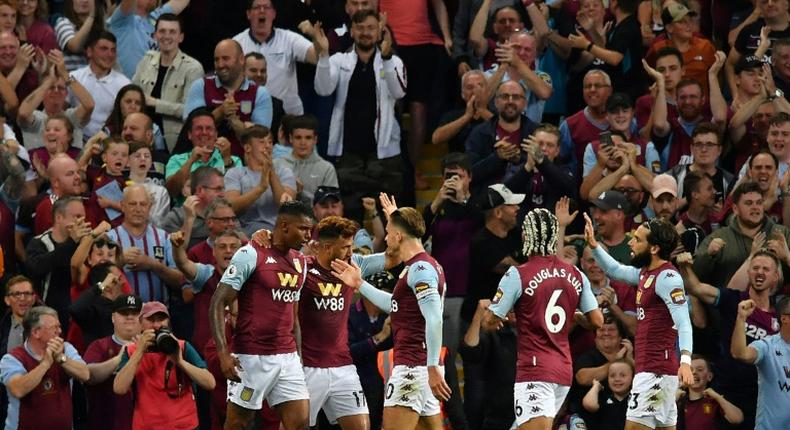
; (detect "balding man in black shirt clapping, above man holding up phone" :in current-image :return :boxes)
[431,70,494,152]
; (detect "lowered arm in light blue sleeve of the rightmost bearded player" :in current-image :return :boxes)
[656,270,694,386]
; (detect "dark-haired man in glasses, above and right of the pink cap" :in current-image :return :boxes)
[668,122,735,204]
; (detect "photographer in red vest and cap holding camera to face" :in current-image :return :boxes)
[113,302,215,430]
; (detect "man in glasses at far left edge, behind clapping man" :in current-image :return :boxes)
[0,276,36,423]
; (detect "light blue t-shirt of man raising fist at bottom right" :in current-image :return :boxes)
[749,334,790,430]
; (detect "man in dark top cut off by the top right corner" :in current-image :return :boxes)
[724,0,790,99]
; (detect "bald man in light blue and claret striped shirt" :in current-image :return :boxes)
[107,185,183,301]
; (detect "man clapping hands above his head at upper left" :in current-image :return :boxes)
[17,50,95,149]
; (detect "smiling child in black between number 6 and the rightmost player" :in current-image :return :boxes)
[582,359,634,430]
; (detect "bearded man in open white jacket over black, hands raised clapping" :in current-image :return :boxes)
[313,10,406,222]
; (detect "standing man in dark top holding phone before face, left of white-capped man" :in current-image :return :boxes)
[422,152,482,357]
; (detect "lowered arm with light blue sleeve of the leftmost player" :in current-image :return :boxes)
[209,245,258,382]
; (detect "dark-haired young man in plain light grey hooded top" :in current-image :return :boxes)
[274,115,338,204]
